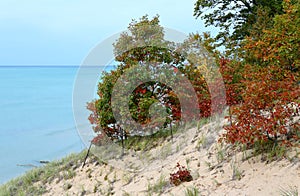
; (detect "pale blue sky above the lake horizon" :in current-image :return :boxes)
[0,0,215,66]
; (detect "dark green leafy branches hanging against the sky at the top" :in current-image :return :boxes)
[194,0,282,46]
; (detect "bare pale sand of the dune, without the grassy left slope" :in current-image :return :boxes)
[38,119,300,196]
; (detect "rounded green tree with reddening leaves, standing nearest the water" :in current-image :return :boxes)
[88,16,186,143]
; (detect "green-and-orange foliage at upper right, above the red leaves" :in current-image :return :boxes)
[244,1,300,72]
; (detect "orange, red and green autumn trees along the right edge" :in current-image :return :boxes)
[223,1,300,147]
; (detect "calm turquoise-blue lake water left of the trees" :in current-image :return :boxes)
[0,66,88,184]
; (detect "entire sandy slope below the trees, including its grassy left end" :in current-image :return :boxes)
[0,118,300,195]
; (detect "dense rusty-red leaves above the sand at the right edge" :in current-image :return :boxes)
[223,66,299,146]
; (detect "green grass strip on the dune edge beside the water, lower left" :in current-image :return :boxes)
[0,151,86,195]
